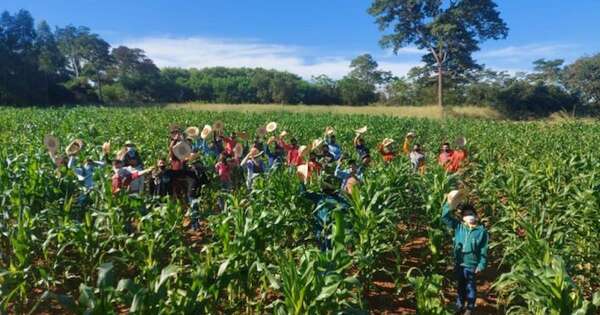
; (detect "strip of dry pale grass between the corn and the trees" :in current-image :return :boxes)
[166,103,504,120]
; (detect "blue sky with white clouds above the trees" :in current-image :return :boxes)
[0,0,600,78]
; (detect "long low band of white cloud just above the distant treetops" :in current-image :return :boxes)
[116,37,418,79]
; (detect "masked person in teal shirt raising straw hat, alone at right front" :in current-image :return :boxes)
[441,190,489,314]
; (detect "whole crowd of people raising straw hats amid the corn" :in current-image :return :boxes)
[44,121,487,314]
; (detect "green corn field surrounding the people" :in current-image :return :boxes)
[0,108,600,315]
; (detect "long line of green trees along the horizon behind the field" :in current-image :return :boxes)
[0,9,600,113]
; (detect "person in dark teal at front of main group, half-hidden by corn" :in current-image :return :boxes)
[300,175,350,251]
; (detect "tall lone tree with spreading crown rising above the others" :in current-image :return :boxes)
[369,0,508,106]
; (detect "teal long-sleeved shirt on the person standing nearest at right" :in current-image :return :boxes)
[442,203,488,271]
